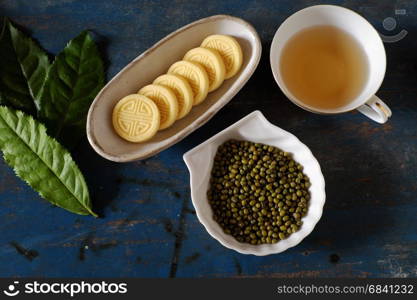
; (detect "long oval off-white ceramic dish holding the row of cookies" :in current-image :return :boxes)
[87,15,262,162]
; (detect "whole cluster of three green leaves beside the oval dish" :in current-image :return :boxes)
[0,18,104,216]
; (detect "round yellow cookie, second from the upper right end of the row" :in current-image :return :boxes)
[183,47,226,92]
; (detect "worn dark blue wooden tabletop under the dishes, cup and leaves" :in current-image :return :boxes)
[0,0,417,277]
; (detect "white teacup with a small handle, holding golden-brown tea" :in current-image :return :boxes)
[270,5,392,124]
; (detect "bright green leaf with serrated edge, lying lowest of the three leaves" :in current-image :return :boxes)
[0,106,97,216]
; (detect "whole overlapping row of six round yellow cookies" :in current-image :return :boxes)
[113,35,242,143]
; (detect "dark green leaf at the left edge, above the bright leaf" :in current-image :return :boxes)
[0,18,50,113]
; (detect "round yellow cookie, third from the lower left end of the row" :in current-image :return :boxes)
[153,74,194,120]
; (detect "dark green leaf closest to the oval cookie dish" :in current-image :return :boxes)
[40,31,104,146]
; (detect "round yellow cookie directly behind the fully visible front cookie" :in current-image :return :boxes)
[138,84,178,130]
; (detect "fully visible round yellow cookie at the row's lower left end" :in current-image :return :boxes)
[112,94,160,143]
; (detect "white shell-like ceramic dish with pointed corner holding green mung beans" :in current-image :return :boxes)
[184,111,326,255]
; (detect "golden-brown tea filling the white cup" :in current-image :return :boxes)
[279,26,368,109]
